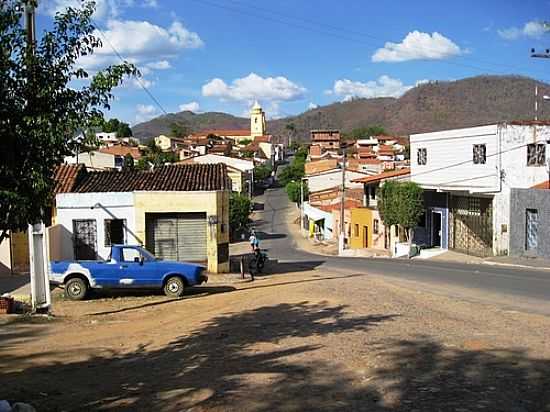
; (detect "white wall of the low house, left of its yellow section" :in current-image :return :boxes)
[55,192,142,259]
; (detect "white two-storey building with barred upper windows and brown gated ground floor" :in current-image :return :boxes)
[410,121,550,256]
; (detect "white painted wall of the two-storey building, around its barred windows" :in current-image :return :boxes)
[411,123,550,255]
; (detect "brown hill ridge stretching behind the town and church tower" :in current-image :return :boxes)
[132,75,550,140]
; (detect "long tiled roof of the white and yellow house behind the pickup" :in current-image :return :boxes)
[70,164,231,193]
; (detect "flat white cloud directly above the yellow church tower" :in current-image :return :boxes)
[202,73,306,101]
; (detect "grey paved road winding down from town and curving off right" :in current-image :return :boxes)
[256,180,550,315]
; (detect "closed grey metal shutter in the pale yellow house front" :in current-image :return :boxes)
[146,213,207,261]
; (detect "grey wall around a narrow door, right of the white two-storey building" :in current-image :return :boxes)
[509,189,550,258]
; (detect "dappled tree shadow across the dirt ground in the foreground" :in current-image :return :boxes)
[0,302,550,412]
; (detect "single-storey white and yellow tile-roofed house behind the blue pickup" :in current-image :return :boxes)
[50,164,230,273]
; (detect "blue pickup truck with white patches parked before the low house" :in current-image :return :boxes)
[50,245,208,300]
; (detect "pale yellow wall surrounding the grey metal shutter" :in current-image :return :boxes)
[135,191,230,273]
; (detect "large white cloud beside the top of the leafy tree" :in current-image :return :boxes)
[80,20,204,70]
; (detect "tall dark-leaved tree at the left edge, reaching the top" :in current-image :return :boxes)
[0,0,138,242]
